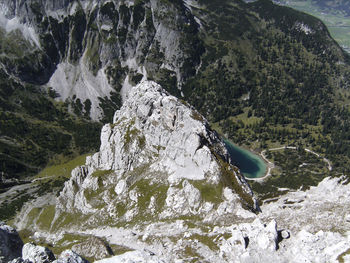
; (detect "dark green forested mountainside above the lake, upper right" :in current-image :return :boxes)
[183,1,350,192]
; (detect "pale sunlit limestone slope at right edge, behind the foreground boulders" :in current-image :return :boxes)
[259,178,350,233]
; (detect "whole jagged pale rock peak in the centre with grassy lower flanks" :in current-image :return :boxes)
[55,81,255,231]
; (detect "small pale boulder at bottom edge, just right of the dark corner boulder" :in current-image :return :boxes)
[22,243,56,263]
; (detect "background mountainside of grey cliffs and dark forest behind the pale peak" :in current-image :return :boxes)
[0,0,350,196]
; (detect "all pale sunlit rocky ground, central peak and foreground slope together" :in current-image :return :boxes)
[0,81,350,262]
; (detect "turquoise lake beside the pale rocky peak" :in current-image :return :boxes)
[224,139,266,178]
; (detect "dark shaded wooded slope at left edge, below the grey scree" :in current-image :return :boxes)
[0,70,101,183]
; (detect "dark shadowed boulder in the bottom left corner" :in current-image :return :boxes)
[0,222,23,263]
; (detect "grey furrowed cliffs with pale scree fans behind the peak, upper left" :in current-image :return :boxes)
[0,0,201,119]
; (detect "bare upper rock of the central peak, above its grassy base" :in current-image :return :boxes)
[87,81,229,184]
